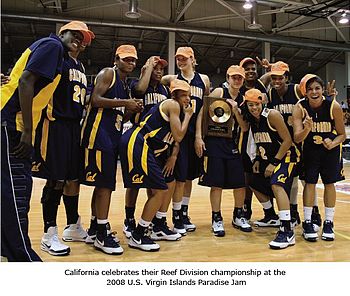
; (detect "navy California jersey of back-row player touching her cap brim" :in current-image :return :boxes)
[130,79,170,124]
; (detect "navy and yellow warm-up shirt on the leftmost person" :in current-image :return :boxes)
[1,34,68,133]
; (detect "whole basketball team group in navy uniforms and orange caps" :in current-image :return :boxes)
[1,21,346,261]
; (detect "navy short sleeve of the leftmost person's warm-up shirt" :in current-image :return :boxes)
[25,40,63,81]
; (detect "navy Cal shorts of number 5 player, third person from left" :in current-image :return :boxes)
[80,148,118,191]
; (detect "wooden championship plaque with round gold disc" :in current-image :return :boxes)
[202,97,233,138]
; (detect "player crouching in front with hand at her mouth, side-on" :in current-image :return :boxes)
[120,79,193,251]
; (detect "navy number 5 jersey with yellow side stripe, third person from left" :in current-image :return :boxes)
[81,69,129,151]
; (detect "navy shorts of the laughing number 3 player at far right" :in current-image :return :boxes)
[303,145,345,184]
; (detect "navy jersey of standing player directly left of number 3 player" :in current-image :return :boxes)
[267,83,300,138]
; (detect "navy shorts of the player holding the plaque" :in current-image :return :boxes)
[198,155,246,189]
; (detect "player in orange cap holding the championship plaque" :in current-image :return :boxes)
[195,65,252,236]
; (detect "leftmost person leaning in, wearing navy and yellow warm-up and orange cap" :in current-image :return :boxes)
[0,22,89,261]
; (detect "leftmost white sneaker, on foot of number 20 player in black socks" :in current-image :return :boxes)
[40,226,70,256]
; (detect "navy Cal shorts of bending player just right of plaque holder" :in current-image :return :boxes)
[250,162,296,197]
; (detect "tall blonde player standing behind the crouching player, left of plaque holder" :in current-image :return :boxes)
[162,47,210,235]
